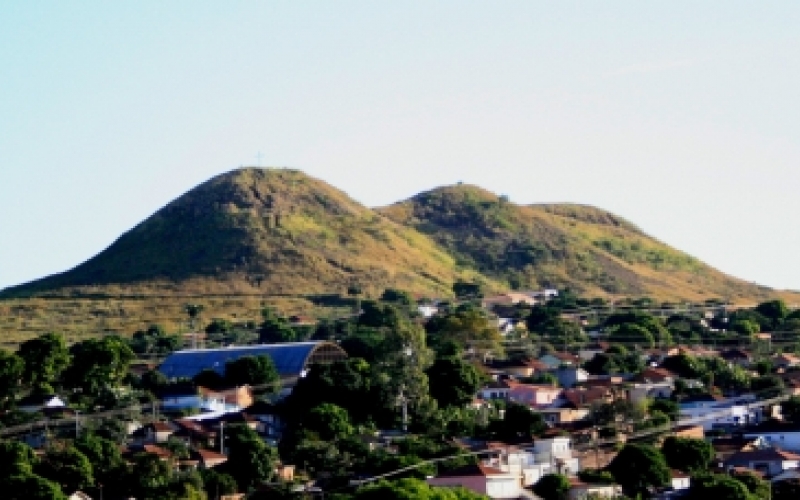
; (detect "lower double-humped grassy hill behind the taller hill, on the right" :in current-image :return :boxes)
[380,185,788,301]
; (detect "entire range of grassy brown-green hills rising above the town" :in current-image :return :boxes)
[0,168,788,300]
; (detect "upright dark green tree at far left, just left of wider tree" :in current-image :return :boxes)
[18,333,70,394]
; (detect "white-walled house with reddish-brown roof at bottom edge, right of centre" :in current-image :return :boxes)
[427,464,522,500]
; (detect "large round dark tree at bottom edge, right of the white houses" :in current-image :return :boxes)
[607,444,670,496]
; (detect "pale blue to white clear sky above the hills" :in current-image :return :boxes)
[0,0,800,290]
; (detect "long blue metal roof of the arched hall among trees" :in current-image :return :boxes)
[158,342,327,378]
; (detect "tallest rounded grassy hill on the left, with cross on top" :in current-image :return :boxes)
[2,168,482,297]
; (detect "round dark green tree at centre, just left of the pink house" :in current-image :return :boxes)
[427,357,483,408]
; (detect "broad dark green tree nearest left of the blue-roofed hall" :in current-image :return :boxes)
[64,336,134,396]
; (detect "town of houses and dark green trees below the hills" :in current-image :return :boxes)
[0,282,800,500]
